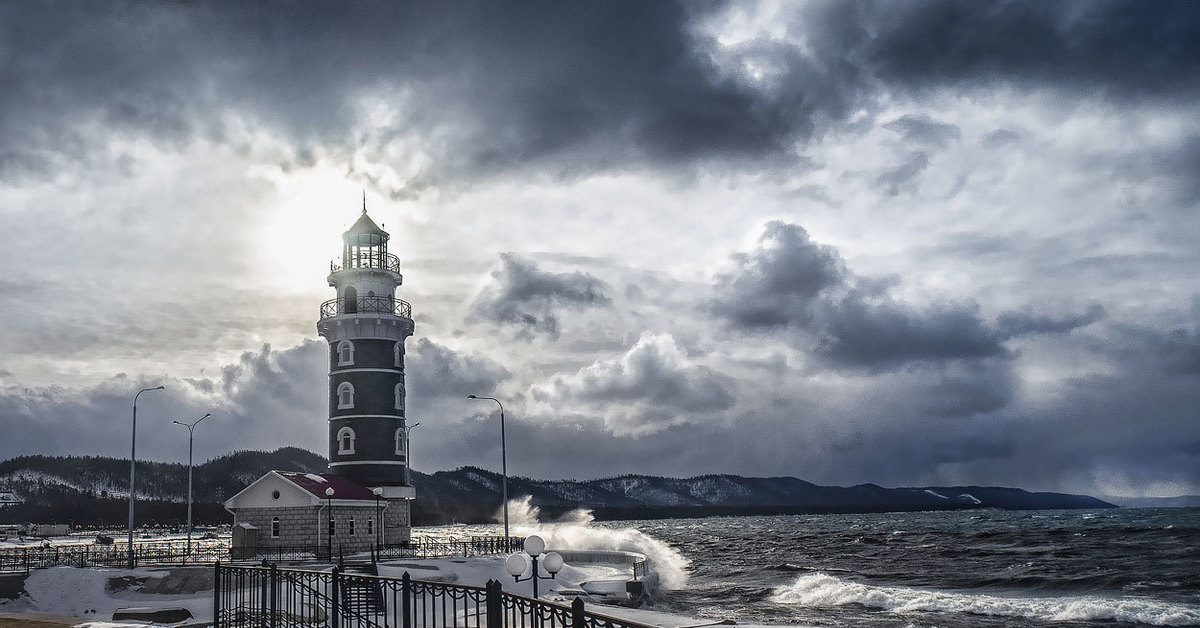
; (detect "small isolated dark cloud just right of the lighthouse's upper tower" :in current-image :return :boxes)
[470,253,610,339]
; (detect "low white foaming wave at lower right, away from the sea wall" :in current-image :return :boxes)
[770,573,1200,626]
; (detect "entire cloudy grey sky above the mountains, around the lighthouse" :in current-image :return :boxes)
[0,0,1200,495]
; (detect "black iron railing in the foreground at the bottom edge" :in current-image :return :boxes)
[212,563,647,628]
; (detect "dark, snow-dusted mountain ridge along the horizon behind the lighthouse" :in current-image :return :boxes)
[0,447,1114,525]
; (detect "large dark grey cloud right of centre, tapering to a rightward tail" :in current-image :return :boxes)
[712,221,1104,370]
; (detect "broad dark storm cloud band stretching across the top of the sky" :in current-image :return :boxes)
[0,1,1200,189]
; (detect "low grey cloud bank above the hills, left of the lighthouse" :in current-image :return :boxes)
[0,341,328,461]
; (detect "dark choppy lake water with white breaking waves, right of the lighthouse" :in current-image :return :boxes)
[420,509,1200,627]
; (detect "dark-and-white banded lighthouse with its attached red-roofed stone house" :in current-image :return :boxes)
[224,198,416,557]
